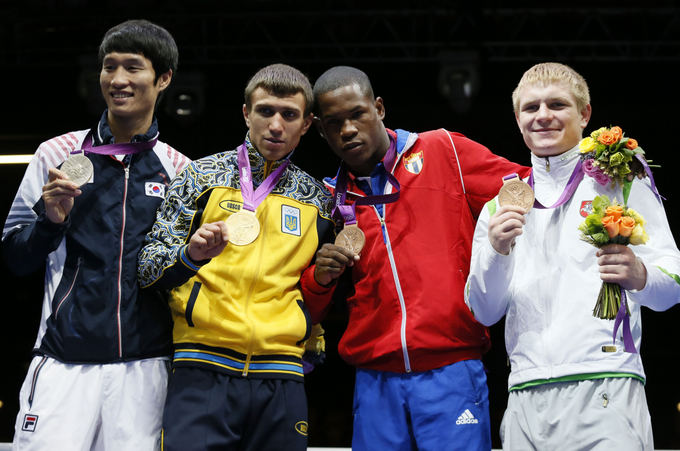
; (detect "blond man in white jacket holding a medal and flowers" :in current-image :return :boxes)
[465,63,680,450]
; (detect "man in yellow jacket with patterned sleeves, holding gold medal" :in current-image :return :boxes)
[139,64,332,451]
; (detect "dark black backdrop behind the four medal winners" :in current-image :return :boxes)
[0,0,680,449]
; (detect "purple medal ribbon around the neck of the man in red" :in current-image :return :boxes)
[332,135,400,225]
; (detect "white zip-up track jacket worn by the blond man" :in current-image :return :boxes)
[465,148,680,387]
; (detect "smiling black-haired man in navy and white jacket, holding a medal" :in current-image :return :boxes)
[2,20,188,450]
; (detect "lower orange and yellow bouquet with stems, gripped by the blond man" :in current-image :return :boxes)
[578,195,649,319]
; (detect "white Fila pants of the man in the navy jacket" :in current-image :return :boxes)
[13,356,168,451]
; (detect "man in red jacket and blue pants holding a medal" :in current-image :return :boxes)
[302,66,526,451]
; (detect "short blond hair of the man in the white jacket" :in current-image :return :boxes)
[512,63,590,112]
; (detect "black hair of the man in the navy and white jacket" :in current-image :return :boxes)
[98,19,179,83]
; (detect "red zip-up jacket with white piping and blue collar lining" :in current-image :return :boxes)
[302,129,529,373]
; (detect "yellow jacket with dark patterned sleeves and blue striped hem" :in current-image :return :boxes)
[138,141,333,379]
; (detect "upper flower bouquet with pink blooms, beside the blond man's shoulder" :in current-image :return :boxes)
[579,127,645,186]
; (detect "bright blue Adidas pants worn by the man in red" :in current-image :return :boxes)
[352,360,491,451]
